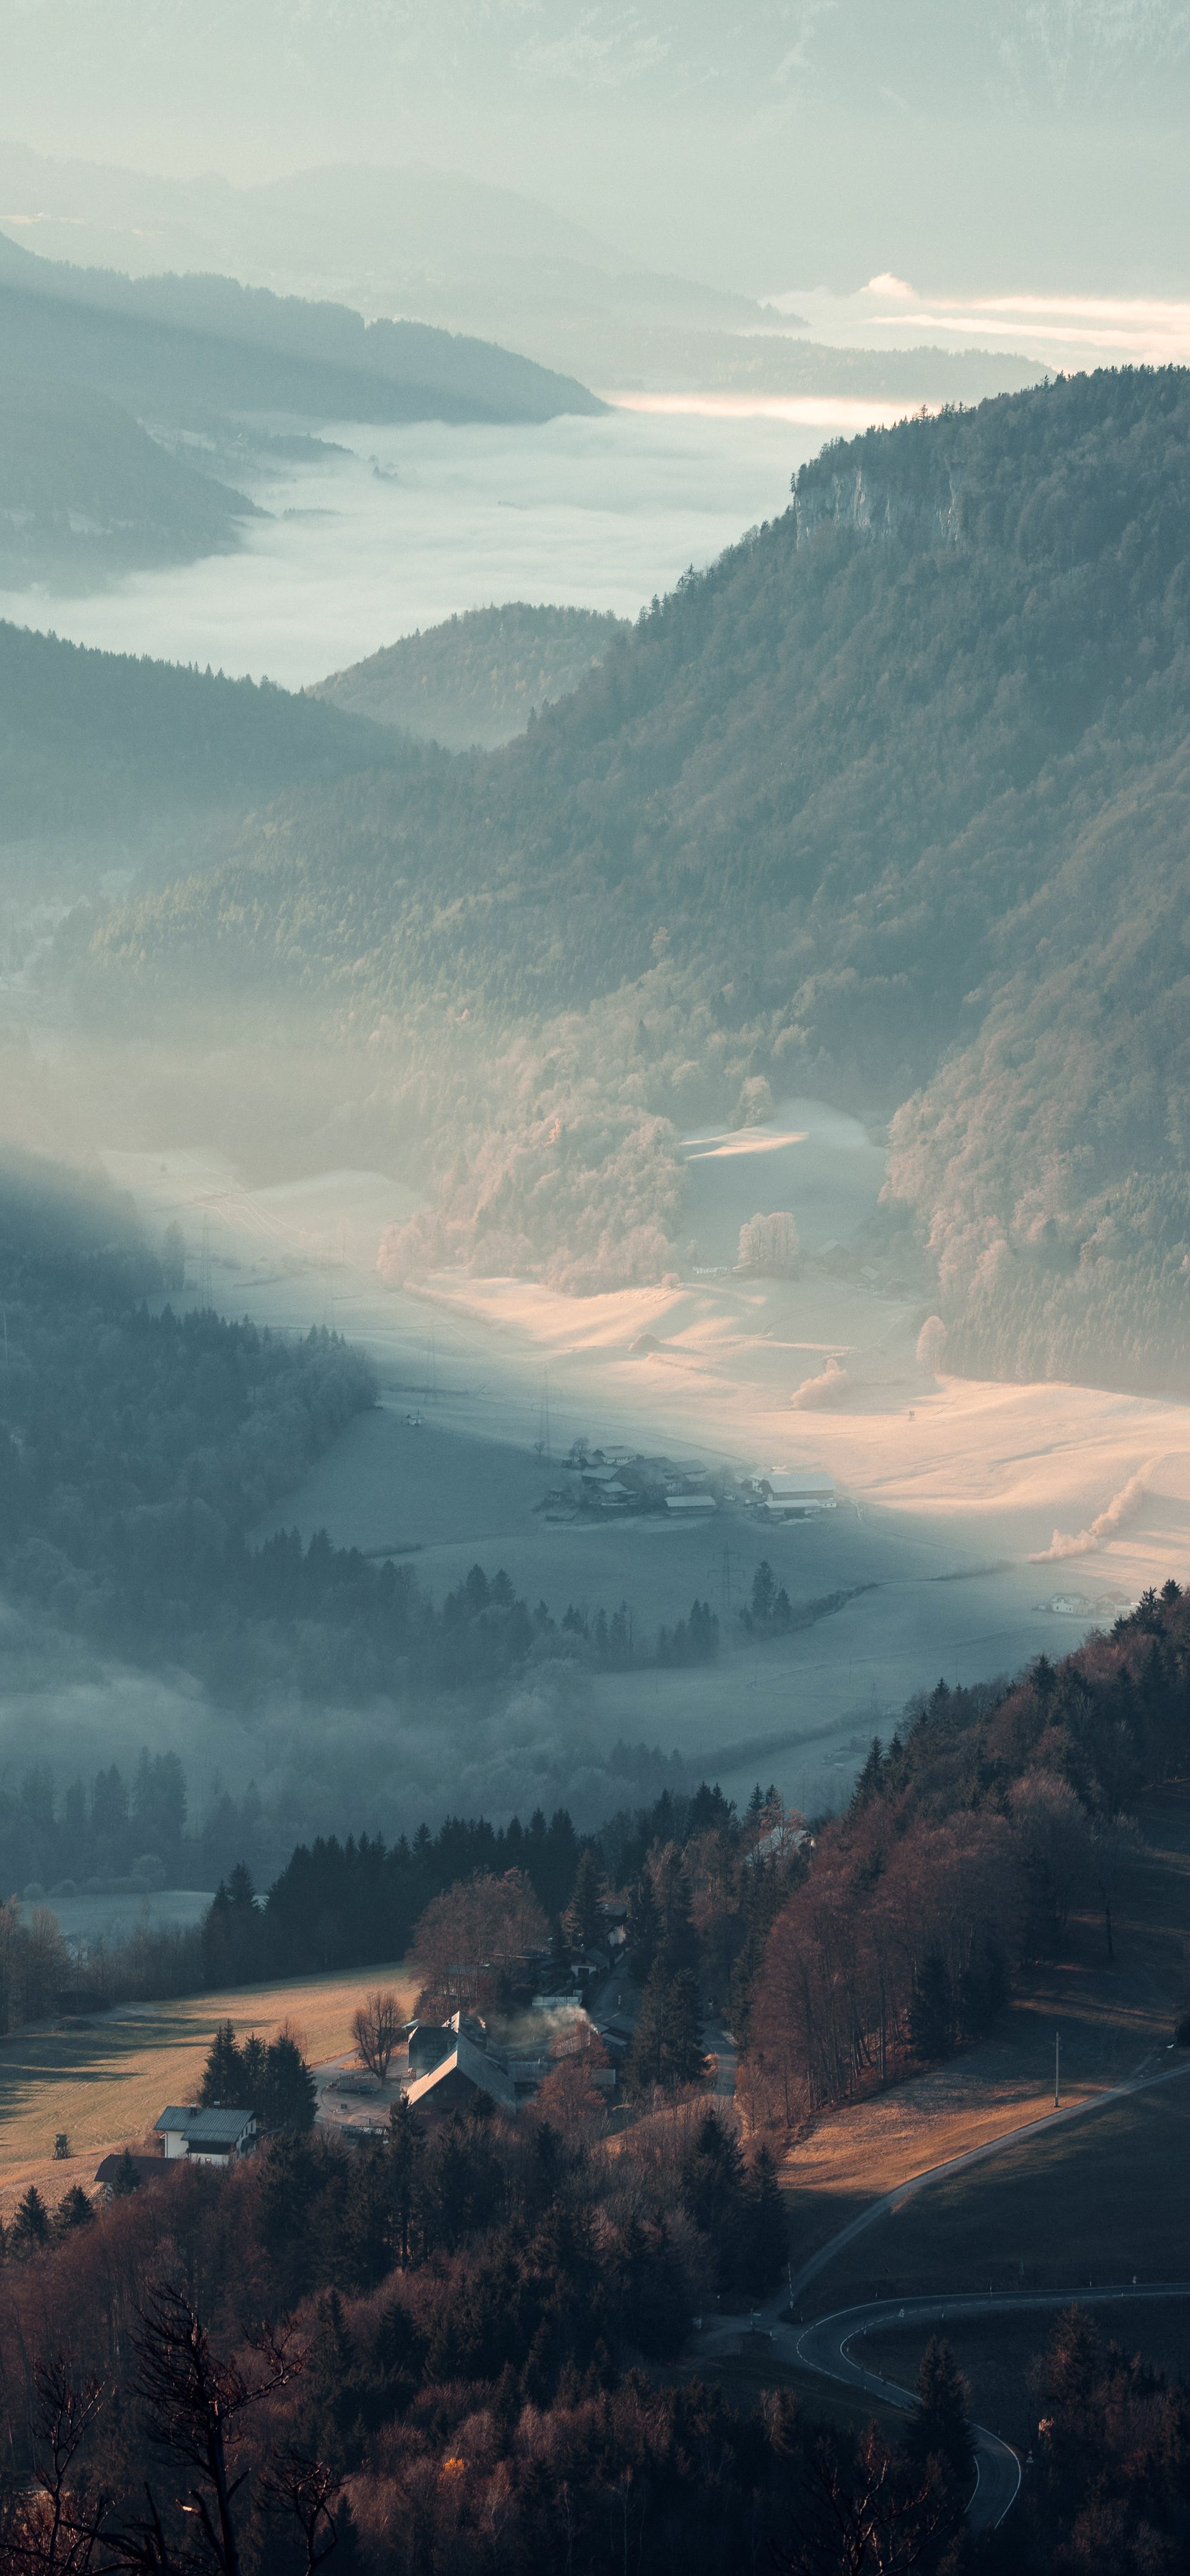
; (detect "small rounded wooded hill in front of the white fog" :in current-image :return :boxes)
[309,600,626,752]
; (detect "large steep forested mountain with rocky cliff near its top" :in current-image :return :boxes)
[81,369,1190,1383]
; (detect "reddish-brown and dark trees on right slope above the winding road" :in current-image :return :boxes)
[745,1582,1190,2123]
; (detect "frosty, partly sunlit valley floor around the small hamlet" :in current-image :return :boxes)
[105,1136,1190,1808]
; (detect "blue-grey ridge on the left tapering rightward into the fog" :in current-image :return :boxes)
[0,232,603,587]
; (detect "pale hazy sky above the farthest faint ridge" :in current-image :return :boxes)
[0,0,1190,296]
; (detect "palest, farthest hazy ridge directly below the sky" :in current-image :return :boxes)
[0,142,1040,407]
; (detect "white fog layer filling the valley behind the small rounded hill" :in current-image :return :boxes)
[0,402,881,688]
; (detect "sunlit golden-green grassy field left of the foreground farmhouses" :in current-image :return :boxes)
[0,1963,412,2218]
